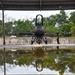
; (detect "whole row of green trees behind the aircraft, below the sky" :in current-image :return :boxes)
[0,10,75,36]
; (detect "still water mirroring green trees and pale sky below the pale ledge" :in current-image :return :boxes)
[0,48,75,75]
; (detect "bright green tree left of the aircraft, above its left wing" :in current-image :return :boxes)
[13,19,33,33]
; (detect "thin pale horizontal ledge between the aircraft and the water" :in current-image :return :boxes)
[0,44,75,48]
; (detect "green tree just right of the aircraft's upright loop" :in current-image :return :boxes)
[44,15,57,32]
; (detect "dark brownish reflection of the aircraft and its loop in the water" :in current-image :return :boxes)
[34,47,45,72]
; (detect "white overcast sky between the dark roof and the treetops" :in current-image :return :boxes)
[0,10,75,20]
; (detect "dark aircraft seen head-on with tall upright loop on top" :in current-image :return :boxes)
[19,14,47,44]
